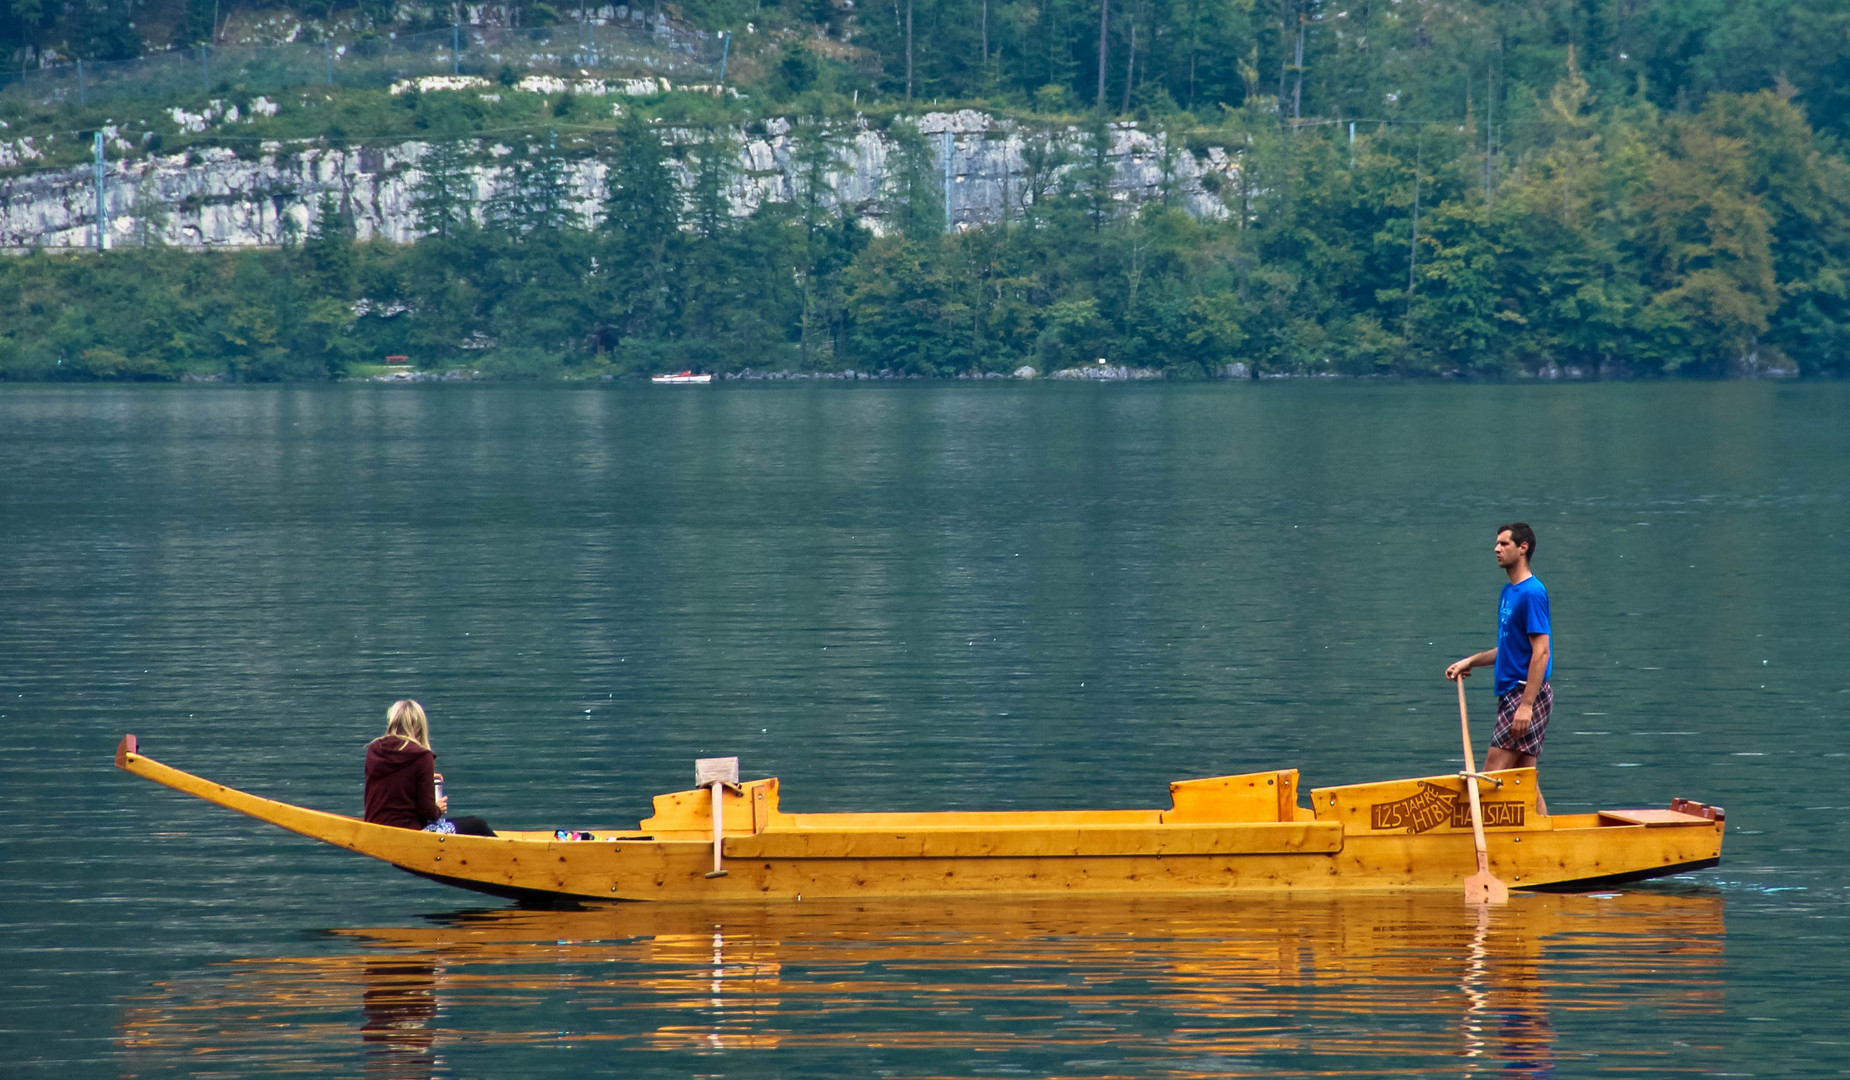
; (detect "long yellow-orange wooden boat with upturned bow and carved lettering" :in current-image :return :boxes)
[117,736,1724,902]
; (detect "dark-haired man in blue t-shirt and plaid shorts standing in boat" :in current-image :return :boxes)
[1445,522,1554,814]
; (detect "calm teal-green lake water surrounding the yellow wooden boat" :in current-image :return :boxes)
[0,383,1850,1080]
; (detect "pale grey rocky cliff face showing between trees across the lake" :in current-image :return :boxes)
[0,111,1238,250]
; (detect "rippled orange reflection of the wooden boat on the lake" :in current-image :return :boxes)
[122,893,1722,1076]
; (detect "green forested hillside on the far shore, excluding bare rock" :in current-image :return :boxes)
[0,0,1850,379]
